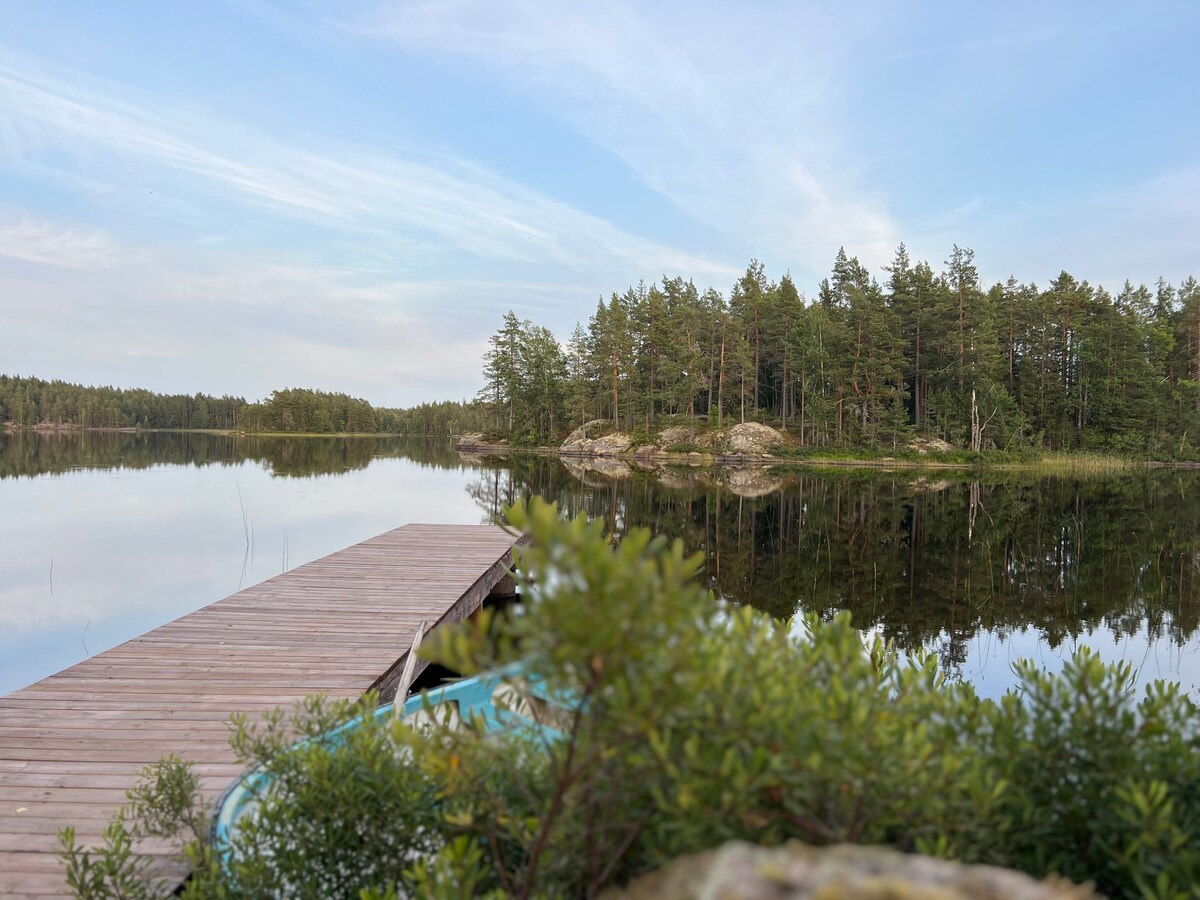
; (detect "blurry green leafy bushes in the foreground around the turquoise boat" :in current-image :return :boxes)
[65,500,1200,898]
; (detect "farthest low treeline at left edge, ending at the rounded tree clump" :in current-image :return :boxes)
[0,374,246,428]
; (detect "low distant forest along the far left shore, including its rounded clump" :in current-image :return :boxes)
[0,376,402,434]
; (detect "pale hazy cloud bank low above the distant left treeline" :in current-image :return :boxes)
[0,223,594,406]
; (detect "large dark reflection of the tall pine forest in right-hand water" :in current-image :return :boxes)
[469,457,1200,667]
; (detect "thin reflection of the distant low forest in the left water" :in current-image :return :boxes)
[0,431,466,479]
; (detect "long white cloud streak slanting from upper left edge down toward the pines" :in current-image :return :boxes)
[0,52,727,276]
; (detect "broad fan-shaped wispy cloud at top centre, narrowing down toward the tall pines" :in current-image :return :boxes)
[354,0,896,274]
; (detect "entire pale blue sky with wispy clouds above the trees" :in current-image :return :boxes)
[0,0,1200,404]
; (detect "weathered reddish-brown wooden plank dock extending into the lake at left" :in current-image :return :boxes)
[0,526,525,896]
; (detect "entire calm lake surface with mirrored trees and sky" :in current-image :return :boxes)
[0,433,1200,697]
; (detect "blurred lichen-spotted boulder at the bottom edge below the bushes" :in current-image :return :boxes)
[601,841,1100,900]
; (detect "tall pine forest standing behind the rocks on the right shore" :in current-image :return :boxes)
[458,245,1200,456]
